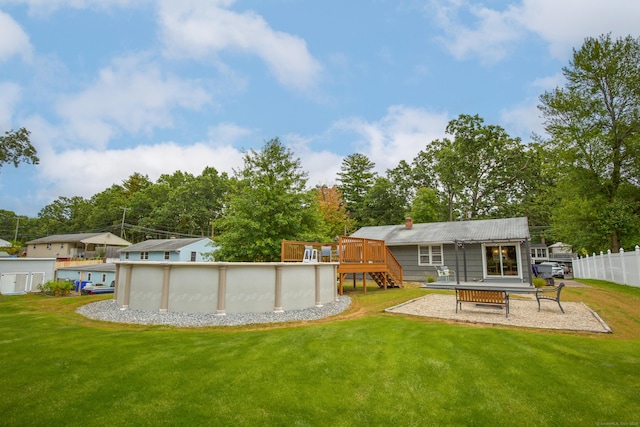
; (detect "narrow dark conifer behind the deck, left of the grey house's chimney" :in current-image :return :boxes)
[338,153,377,227]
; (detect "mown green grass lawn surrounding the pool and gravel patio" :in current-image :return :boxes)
[0,281,640,426]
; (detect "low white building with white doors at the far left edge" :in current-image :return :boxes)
[0,258,56,294]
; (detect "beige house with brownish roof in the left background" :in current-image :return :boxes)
[26,233,131,260]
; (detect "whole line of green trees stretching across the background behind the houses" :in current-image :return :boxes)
[0,35,640,261]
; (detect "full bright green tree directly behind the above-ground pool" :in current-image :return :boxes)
[216,138,319,261]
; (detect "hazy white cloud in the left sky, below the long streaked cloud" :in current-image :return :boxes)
[56,58,211,148]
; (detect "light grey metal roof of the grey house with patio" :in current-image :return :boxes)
[351,217,530,246]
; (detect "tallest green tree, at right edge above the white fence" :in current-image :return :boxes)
[539,35,640,251]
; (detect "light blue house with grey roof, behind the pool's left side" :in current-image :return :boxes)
[118,237,214,262]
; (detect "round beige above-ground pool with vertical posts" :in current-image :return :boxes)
[114,261,338,315]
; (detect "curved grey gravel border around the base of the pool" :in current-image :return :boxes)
[76,295,351,328]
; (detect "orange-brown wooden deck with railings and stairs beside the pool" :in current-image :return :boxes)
[281,236,402,295]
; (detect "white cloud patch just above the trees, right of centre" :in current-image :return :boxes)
[335,105,450,173]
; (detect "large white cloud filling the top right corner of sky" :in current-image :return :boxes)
[425,0,640,63]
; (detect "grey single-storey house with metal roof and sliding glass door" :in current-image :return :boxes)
[352,218,531,283]
